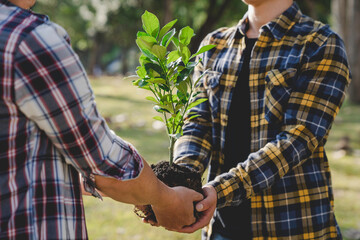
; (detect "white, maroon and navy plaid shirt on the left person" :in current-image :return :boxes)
[0,0,143,239]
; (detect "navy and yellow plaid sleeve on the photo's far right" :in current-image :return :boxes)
[209,31,351,208]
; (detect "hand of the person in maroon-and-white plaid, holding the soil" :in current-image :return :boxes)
[152,187,204,232]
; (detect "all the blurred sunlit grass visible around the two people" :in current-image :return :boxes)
[84,77,360,240]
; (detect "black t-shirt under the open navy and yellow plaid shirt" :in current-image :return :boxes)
[213,38,257,240]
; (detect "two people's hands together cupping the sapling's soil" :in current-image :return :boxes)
[144,185,217,233]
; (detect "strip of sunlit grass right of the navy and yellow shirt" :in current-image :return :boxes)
[326,98,360,239]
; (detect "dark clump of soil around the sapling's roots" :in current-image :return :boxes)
[134,161,203,222]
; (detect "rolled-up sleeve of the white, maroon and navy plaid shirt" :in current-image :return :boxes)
[14,24,143,197]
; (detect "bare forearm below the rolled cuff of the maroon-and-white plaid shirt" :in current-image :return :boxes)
[95,161,172,205]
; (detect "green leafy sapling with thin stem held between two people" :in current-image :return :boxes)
[133,11,214,165]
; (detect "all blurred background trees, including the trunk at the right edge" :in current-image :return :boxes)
[35,0,360,103]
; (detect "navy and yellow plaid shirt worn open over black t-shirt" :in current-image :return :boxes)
[175,3,350,240]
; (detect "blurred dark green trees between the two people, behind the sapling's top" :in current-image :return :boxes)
[35,0,246,74]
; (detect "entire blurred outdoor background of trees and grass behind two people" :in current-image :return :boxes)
[34,0,360,240]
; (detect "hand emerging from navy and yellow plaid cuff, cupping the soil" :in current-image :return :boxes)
[177,185,217,233]
